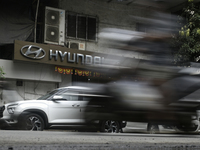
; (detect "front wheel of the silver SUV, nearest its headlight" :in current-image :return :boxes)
[20,113,44,131]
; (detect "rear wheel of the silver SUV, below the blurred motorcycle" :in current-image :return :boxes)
[101,120,120,133]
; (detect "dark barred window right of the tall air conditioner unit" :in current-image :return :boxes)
[65,12,97,41]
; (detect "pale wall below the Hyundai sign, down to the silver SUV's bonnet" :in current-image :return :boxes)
[0,59,72,101]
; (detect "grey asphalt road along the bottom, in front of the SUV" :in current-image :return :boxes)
[0,130,200,150]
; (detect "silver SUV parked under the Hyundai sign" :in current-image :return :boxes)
[0,86,126,132]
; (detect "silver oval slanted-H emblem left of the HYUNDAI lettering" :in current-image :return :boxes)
[21,45,46,59]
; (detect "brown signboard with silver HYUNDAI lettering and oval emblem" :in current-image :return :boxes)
[14,40,108,68]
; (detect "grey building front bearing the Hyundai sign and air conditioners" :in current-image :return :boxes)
[0,0,185,103]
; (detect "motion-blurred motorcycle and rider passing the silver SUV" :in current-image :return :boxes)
[85,20,200,132]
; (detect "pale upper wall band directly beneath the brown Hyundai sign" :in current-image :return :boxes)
[0,59,61,82]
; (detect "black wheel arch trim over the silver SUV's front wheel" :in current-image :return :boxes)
[19,109,49,128]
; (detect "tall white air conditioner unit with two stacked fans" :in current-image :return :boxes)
[44,7,65,45]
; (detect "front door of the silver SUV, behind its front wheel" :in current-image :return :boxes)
[49,90,81,124]
